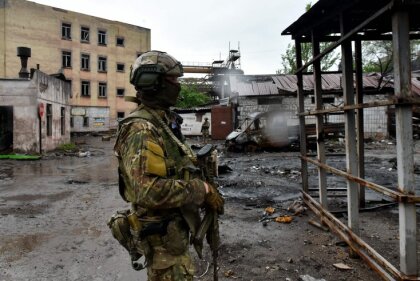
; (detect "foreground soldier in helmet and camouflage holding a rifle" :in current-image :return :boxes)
[114,51,224,281]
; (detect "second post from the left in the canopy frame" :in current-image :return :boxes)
[312,32,328,209]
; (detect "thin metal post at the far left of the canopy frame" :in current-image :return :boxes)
[295,40,309,192]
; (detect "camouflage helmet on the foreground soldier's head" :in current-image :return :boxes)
[130,51,184,90]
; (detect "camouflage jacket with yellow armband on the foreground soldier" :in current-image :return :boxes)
[114,105,205,210]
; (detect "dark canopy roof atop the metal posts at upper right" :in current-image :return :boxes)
[282,0,420,42]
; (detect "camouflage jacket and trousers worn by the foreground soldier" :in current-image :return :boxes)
[115,105,205,281]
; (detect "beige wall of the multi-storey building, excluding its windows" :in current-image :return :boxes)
[0,0,151,129]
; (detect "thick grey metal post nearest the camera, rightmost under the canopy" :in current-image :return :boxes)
[392,10,417,275]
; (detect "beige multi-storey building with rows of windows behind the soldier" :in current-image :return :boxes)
[0,0,151,132]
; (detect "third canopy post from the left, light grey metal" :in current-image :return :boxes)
[340,14,359,234]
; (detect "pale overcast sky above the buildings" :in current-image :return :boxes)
[32,0,308,74]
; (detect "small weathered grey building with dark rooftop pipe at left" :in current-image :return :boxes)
[0,48,71,154]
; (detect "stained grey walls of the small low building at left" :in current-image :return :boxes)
[0,71,70,153]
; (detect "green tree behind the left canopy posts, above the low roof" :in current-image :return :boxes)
[276,3,339,74]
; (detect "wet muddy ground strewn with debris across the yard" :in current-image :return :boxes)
[0,136,420,281]
